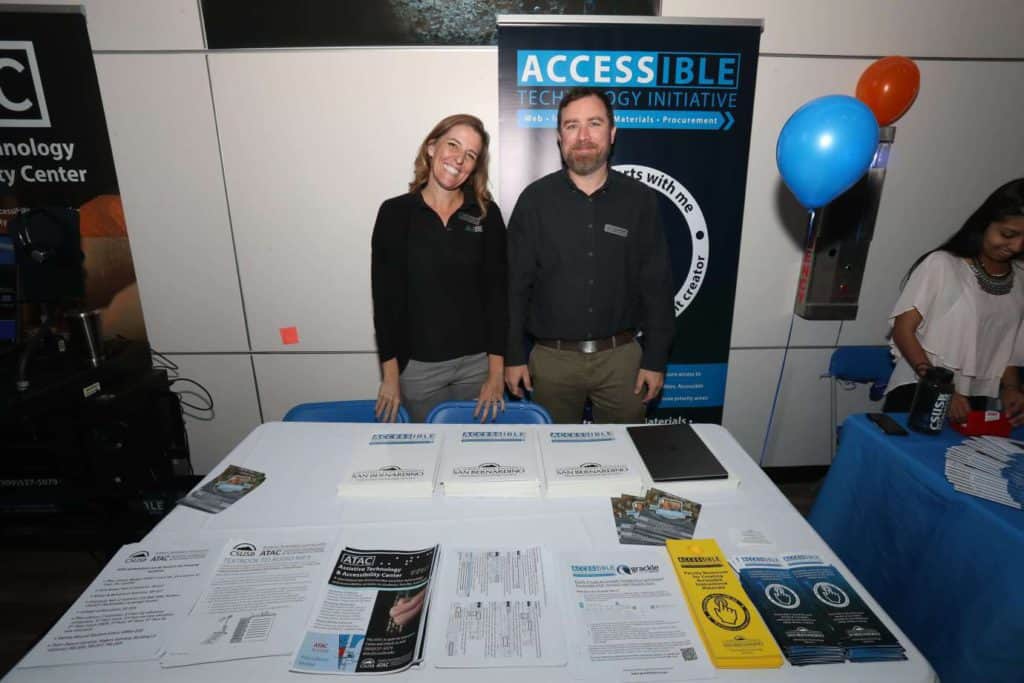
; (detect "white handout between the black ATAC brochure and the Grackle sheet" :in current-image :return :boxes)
[427,548,566,669]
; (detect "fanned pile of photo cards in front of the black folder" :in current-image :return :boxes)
[611,488,700,546]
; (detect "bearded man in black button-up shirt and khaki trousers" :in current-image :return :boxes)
[505,88,675,424]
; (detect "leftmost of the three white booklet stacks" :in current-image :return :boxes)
[338,427,441,498]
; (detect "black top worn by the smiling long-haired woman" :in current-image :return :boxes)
[371,191,508,369]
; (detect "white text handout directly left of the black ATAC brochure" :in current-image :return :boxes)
[160,528,338,667]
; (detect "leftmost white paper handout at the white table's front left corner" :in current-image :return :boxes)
[19,539,220,667]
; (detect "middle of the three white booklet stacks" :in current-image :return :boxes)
[440,425,541,498]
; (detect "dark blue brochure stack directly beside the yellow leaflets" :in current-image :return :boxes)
[732,555,846,667]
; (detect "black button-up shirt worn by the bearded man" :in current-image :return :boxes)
[505,170,675,372]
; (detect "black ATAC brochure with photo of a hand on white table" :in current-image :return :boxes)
[292,546,438,675]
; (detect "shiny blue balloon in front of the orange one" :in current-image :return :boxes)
[775,95,879,209]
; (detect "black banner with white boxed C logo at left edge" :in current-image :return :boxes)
[0,5,145,340]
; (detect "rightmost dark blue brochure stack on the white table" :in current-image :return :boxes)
[778,553,906,661]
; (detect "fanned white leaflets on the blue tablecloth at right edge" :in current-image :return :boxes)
[946,436,1024,510]
